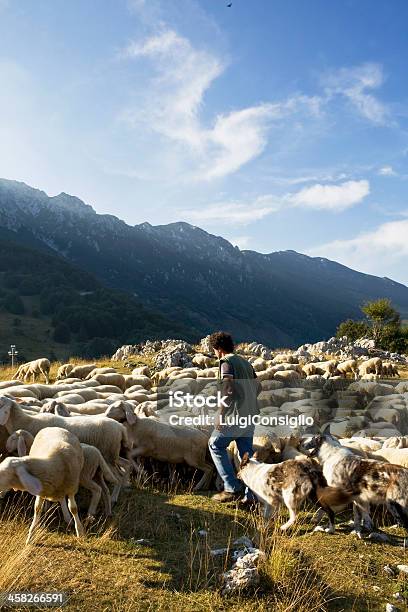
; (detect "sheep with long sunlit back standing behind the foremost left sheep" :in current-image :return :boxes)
[0,396,131,488]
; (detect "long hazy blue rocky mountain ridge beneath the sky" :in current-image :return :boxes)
[0,180,408,346]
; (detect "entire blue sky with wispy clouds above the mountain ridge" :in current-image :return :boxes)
[0,0,408,283]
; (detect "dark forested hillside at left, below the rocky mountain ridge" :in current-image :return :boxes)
[0,239,196,362]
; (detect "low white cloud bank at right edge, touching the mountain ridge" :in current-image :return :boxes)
[309,219,408,283]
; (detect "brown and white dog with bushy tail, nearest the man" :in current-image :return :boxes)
[237,453,351,532]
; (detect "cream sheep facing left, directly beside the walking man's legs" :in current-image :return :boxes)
[125,411,213,491]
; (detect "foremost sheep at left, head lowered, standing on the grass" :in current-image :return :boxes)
[0,427,85,544]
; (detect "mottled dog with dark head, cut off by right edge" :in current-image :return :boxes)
[300,434,408,537]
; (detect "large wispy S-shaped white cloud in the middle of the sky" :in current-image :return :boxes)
[121,28,320,180]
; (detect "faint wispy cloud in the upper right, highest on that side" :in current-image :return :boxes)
[324,63,390,125]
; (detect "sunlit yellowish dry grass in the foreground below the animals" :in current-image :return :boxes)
[0,359,408,612]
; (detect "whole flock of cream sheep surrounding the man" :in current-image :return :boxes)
[0,347,408,540]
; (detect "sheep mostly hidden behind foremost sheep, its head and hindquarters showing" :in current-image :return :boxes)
[6,429,118,523]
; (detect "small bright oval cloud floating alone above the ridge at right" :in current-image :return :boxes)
[290,180,370,211]
